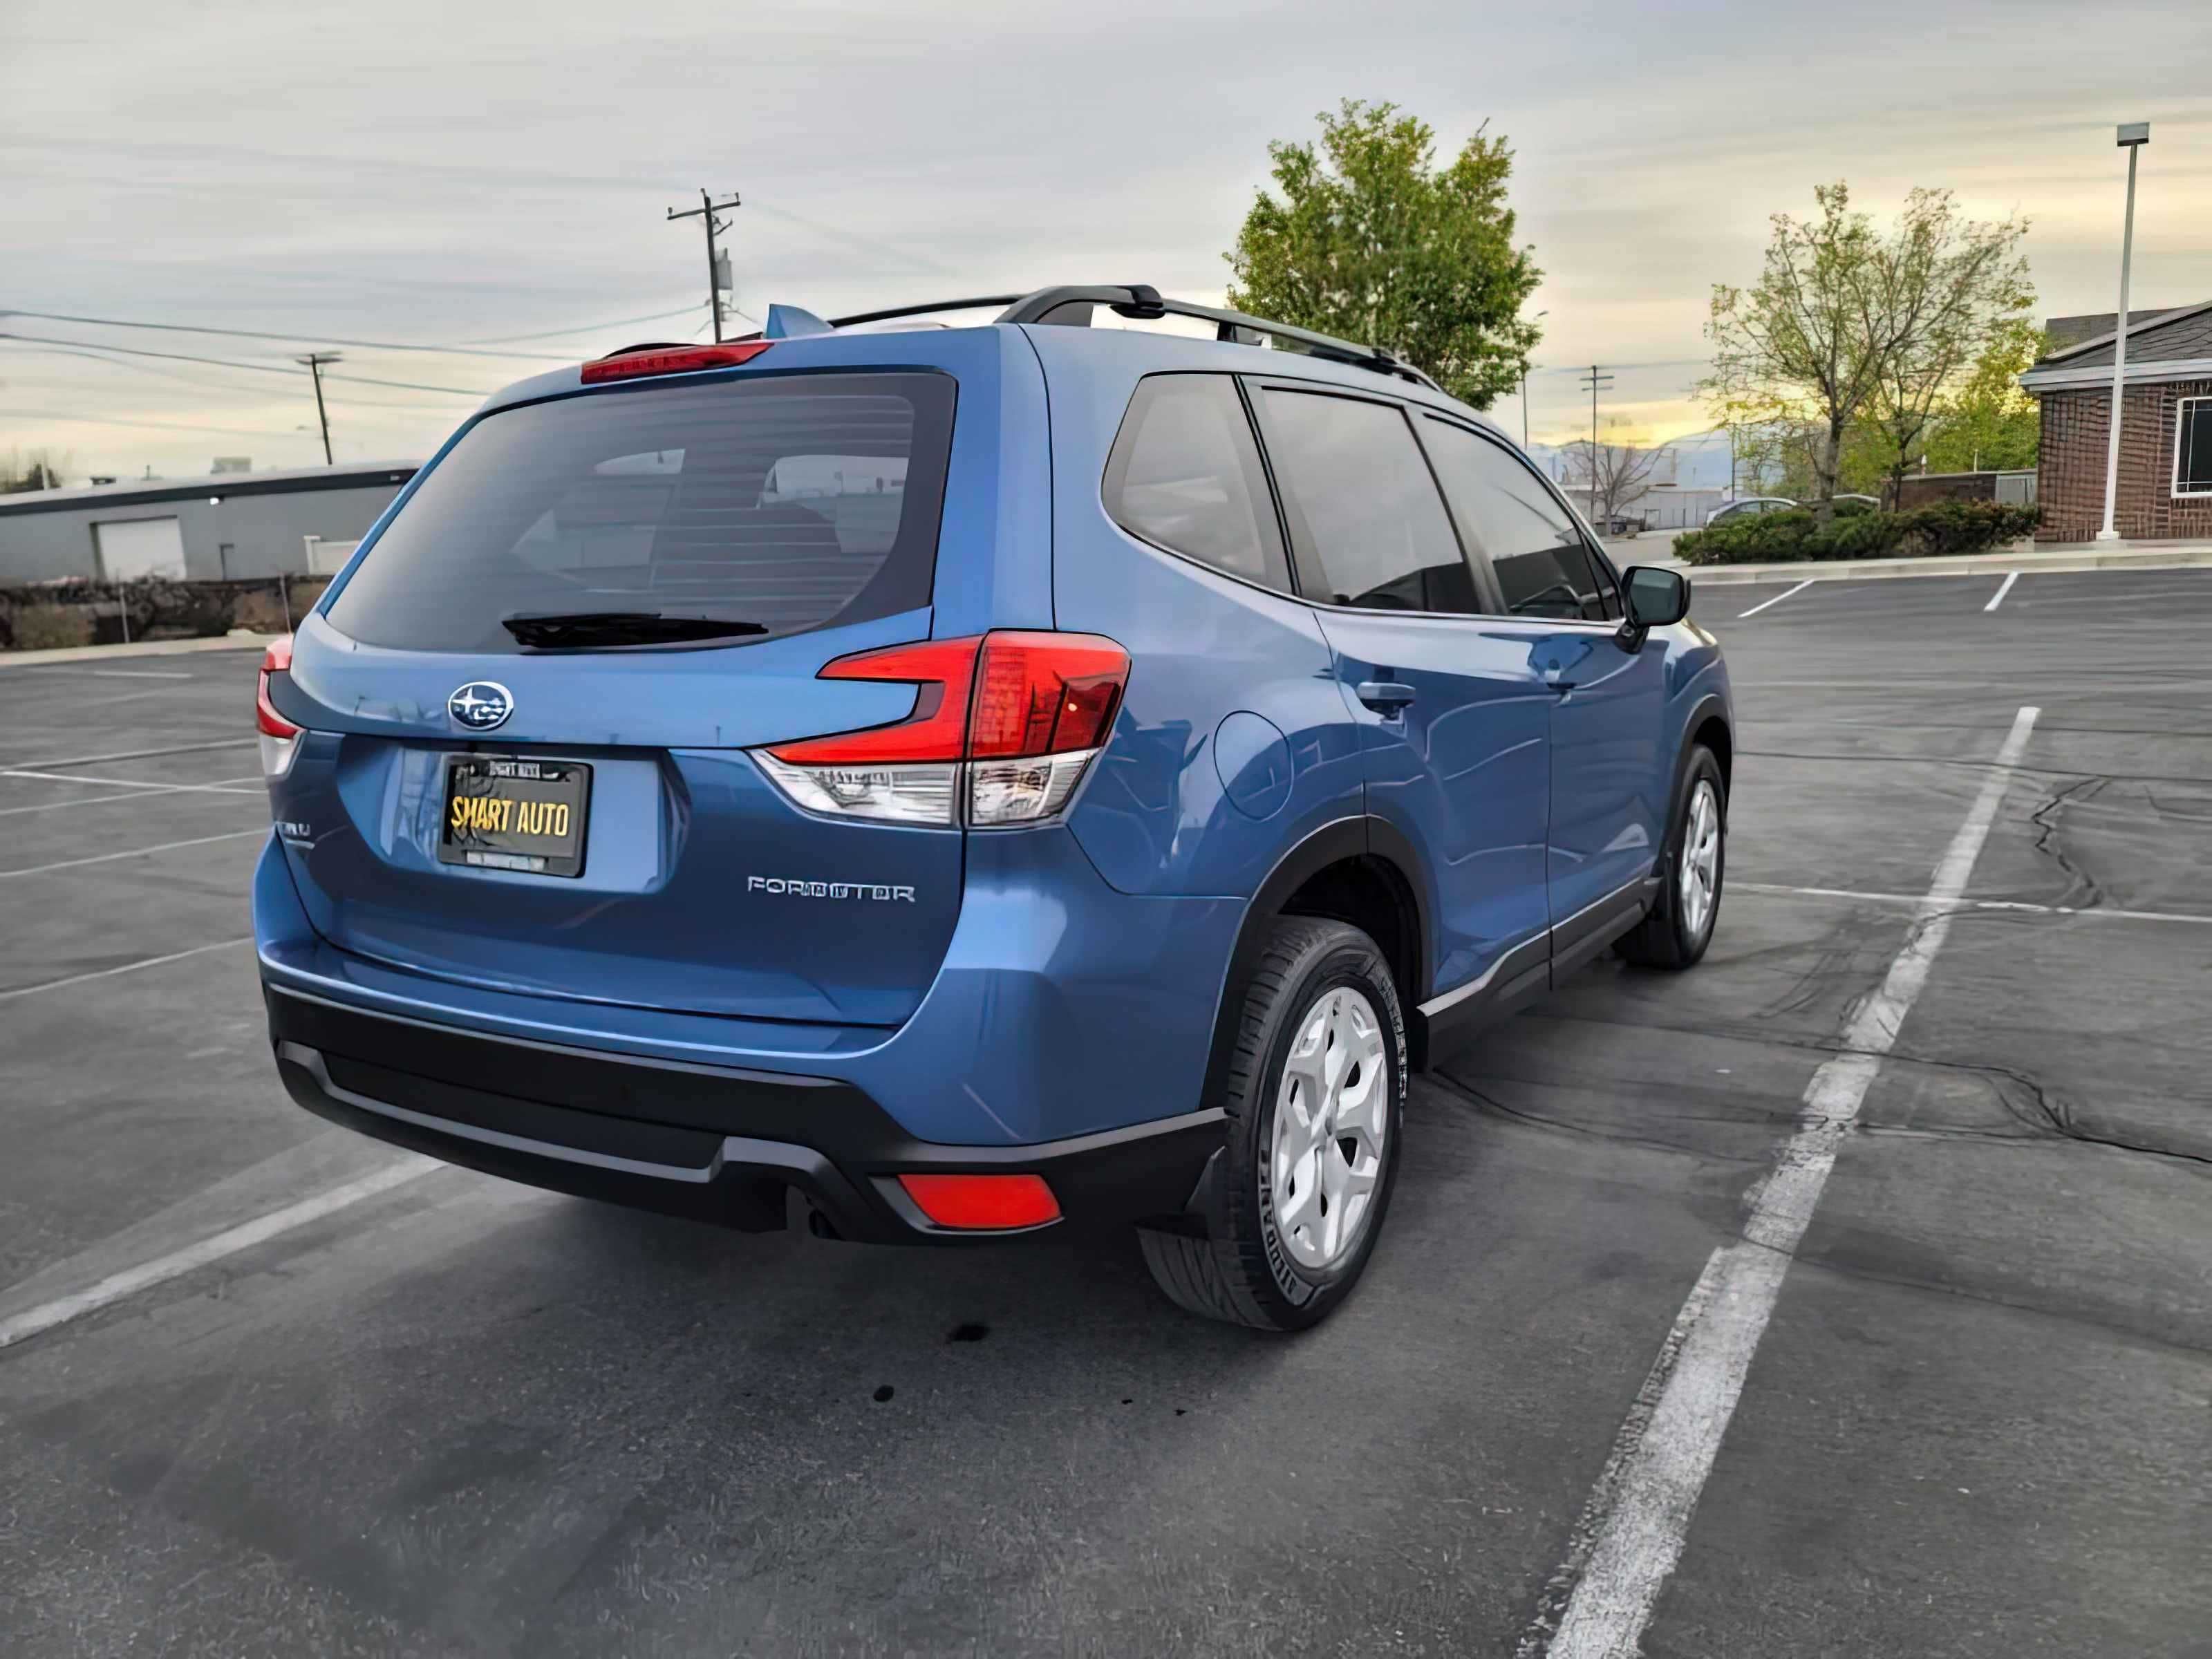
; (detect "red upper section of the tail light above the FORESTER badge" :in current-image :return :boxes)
[770,632,1128,765]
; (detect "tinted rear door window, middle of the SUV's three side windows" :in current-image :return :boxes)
[1263,387,1482,615]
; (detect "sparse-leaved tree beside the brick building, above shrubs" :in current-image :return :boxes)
[1699,181,2035,516]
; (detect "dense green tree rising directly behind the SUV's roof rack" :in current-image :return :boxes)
[1226,97,1541,409]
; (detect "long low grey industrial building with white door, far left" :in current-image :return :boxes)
[0,460,420,588]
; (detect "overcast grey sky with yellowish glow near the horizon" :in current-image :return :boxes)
[0,0,2212,487]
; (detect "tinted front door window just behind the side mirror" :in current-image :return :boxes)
[1423,420,1619,621]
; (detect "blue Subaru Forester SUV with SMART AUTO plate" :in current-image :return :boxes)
[254,285,1734,1329]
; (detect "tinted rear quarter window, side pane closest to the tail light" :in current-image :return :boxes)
[1106,374,1290,593]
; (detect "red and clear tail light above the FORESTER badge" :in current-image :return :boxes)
[754,632,1128,830]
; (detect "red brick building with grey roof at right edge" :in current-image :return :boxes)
[2020,301,2212,542]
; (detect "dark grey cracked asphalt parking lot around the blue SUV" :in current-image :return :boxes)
[0,571,2212,1659]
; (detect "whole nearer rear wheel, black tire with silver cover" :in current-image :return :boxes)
[1137,916,1407,1331]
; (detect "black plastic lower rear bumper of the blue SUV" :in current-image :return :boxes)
[263,982,1224,1243]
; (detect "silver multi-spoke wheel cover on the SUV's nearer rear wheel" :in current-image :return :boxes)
[1268,984,1389,1270]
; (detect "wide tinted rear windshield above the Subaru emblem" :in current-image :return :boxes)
[330,372,953,650]
